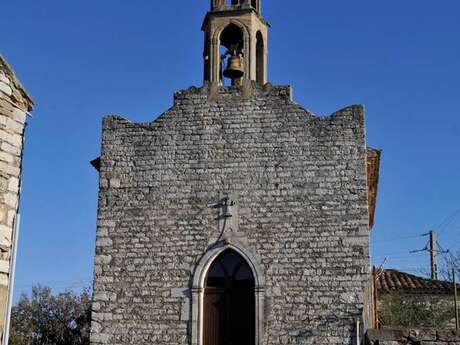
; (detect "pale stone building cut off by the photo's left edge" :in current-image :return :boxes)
[0,55,34,338]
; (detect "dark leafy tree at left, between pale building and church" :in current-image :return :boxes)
[9,286,91,345]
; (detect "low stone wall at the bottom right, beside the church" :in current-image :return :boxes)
[365,328,460,345]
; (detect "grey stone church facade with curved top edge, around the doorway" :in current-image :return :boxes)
[91,85,369,345]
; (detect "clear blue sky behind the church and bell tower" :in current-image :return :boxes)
[0,0,460,296]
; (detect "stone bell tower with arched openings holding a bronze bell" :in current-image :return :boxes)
[202,0,270,85]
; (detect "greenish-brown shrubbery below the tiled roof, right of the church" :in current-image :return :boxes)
[379,293,455,329]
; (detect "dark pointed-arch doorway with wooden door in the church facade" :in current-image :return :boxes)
[203,249,256,345]
